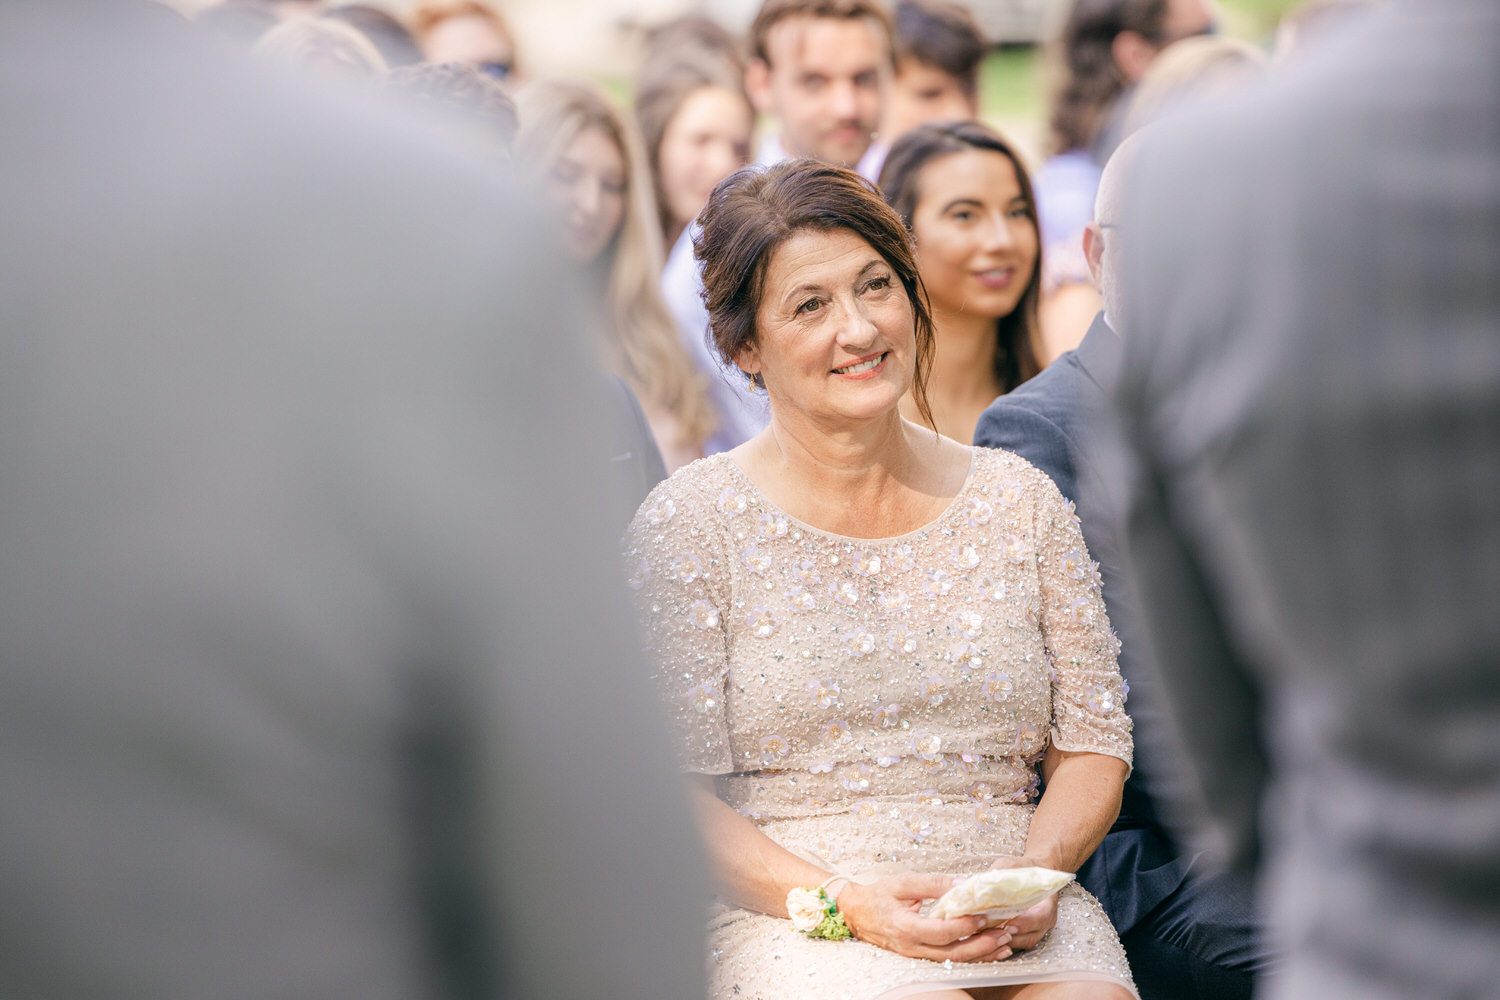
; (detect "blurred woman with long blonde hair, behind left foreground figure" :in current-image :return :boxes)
[516,81,714,472]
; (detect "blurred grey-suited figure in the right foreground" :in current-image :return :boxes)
[1119,0,1500,1000]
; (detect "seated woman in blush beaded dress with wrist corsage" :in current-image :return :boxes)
[627,160,1134,1000]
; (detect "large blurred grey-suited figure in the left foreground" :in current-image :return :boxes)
[0,0,704,1000]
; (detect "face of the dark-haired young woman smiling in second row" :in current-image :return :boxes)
[912,150,1038,319]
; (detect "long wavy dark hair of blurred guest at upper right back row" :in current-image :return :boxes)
[1047,0,1167,153]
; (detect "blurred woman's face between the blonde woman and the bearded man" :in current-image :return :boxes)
[657,87,753,226]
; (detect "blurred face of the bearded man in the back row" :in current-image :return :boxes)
[746,16,891,168]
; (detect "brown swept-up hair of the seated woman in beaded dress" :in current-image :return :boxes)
[693,159,935,426]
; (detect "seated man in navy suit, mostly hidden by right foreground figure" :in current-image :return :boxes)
[975,139,1266,1000]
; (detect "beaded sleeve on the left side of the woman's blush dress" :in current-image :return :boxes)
[624,477,734,774]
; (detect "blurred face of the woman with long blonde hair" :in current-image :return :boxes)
[546,127,629,264]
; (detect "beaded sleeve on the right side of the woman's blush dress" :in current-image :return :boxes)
[1035,472,1134,763]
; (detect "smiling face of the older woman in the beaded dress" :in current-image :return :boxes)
[735,229,917,427]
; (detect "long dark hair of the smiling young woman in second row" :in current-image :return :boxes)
[881,121,1041,393]
